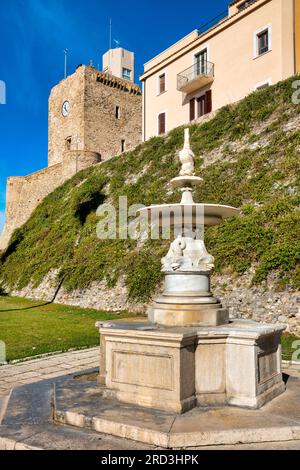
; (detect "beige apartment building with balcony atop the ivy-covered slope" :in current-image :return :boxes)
[140,0,300,140]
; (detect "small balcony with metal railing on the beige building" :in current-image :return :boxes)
[177,61,215,93]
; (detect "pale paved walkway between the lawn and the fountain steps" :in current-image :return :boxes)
[0,347,99,397]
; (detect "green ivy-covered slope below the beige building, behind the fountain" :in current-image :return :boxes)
[0,77,300,301]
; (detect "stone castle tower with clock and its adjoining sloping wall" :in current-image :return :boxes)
[0,48,142,250]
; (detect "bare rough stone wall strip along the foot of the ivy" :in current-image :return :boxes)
[10,271,300,335]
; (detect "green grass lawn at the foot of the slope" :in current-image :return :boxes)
[0,296,144,362]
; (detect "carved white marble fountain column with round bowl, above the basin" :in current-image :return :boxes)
[148,129,234,326]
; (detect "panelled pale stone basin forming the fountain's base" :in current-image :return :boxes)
[97,320,285,413]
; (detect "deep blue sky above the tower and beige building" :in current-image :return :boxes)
[0,0,229,232]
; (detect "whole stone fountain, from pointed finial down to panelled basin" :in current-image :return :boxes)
[97,129,285,413]
